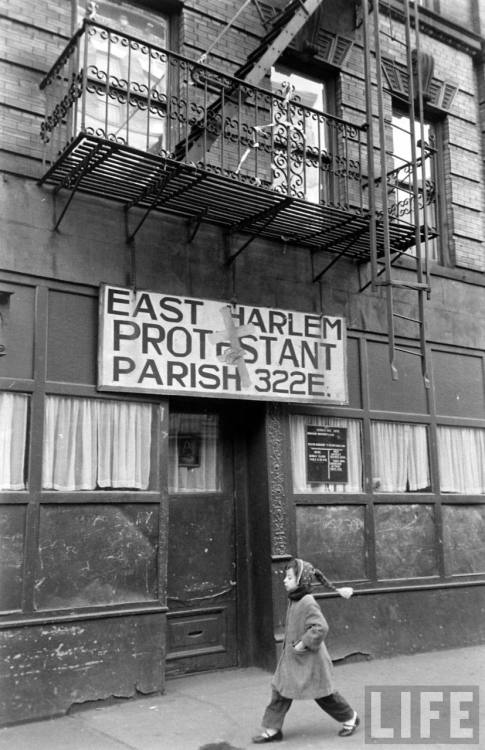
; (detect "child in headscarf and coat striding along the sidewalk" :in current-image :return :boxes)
[253,558,360,744]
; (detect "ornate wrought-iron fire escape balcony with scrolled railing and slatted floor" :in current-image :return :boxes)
[40,20,424,261]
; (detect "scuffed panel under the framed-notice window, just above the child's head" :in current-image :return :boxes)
[296,505,366,581]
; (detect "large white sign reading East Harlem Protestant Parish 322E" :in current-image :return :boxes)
[98,285,347,404]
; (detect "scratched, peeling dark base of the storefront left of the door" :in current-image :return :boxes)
[0,613,165,728]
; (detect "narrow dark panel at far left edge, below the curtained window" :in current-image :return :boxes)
[0,505,25,611]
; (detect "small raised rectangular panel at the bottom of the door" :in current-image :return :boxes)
[167,608,227,659]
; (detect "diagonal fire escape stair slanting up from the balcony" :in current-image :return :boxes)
[174,0,324,163]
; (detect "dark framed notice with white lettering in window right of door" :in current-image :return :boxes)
[306,425,349,484]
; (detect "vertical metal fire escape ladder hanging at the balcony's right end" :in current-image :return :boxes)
[361,0,430,388]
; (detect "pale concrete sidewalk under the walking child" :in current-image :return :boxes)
[0,646,485,750]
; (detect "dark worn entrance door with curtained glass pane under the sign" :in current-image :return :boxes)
[167,409,237,675]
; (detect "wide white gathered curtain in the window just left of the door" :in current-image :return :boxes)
[42,396,152,491]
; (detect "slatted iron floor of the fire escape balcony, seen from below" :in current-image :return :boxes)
[40,133,415,262]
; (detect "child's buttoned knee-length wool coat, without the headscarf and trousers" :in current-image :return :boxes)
[272,594,335,700]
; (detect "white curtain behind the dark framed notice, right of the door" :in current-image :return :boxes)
[290,414,362,494]
